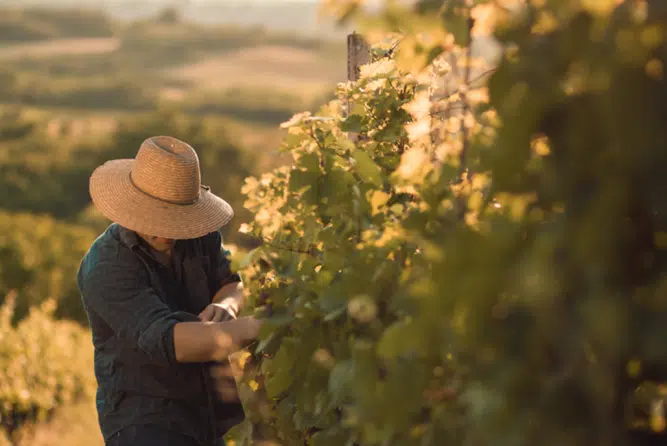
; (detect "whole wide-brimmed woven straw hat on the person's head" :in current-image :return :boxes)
[90,136,234,239]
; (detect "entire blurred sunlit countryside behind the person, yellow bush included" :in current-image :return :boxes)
[0,2,346,446]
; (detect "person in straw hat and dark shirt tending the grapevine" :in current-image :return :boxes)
[77,136,261,446]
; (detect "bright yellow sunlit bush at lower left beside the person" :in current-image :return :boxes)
[0,295,95,438]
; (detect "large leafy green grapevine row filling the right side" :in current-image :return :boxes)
[231,0,667,446]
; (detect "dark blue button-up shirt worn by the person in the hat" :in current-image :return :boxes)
[77,224,244,444]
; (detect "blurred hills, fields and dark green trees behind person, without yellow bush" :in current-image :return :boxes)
[0,2,345,323]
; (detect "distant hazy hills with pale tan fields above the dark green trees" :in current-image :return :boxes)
[0,8,346,132]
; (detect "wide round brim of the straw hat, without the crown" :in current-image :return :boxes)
[90,159,234,240]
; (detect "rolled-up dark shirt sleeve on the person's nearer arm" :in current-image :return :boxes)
[79,261,199,364]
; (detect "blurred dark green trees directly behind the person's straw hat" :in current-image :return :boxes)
[0,109,264,324]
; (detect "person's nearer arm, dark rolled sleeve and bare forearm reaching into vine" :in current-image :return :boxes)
[79,257,260,364]
